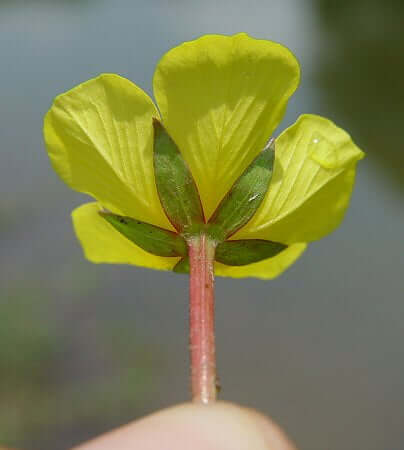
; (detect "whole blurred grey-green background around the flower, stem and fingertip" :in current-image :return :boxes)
[0,0,404,450]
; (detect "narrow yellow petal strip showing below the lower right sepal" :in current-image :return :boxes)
[215,243,307,280]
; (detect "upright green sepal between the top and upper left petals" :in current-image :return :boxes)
[153,119,205,232]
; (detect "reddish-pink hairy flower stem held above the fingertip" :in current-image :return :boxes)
[188,235,216,403]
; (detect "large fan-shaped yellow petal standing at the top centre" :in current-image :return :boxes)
[153,33,299,217]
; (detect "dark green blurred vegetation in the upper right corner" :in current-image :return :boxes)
[314,0,404,192]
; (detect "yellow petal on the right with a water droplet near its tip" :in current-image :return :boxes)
[238,114,364,244]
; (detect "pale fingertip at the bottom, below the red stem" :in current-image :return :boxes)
[72,402,296,450]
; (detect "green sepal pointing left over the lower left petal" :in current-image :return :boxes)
[99,211,187,256]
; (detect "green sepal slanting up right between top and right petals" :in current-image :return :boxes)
[209,139,275,241]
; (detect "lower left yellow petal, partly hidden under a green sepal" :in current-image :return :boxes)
[72,203,180,270]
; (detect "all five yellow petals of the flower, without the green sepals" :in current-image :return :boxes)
[44,33,363,279]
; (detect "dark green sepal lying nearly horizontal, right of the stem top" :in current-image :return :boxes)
[215,239,287,266]
